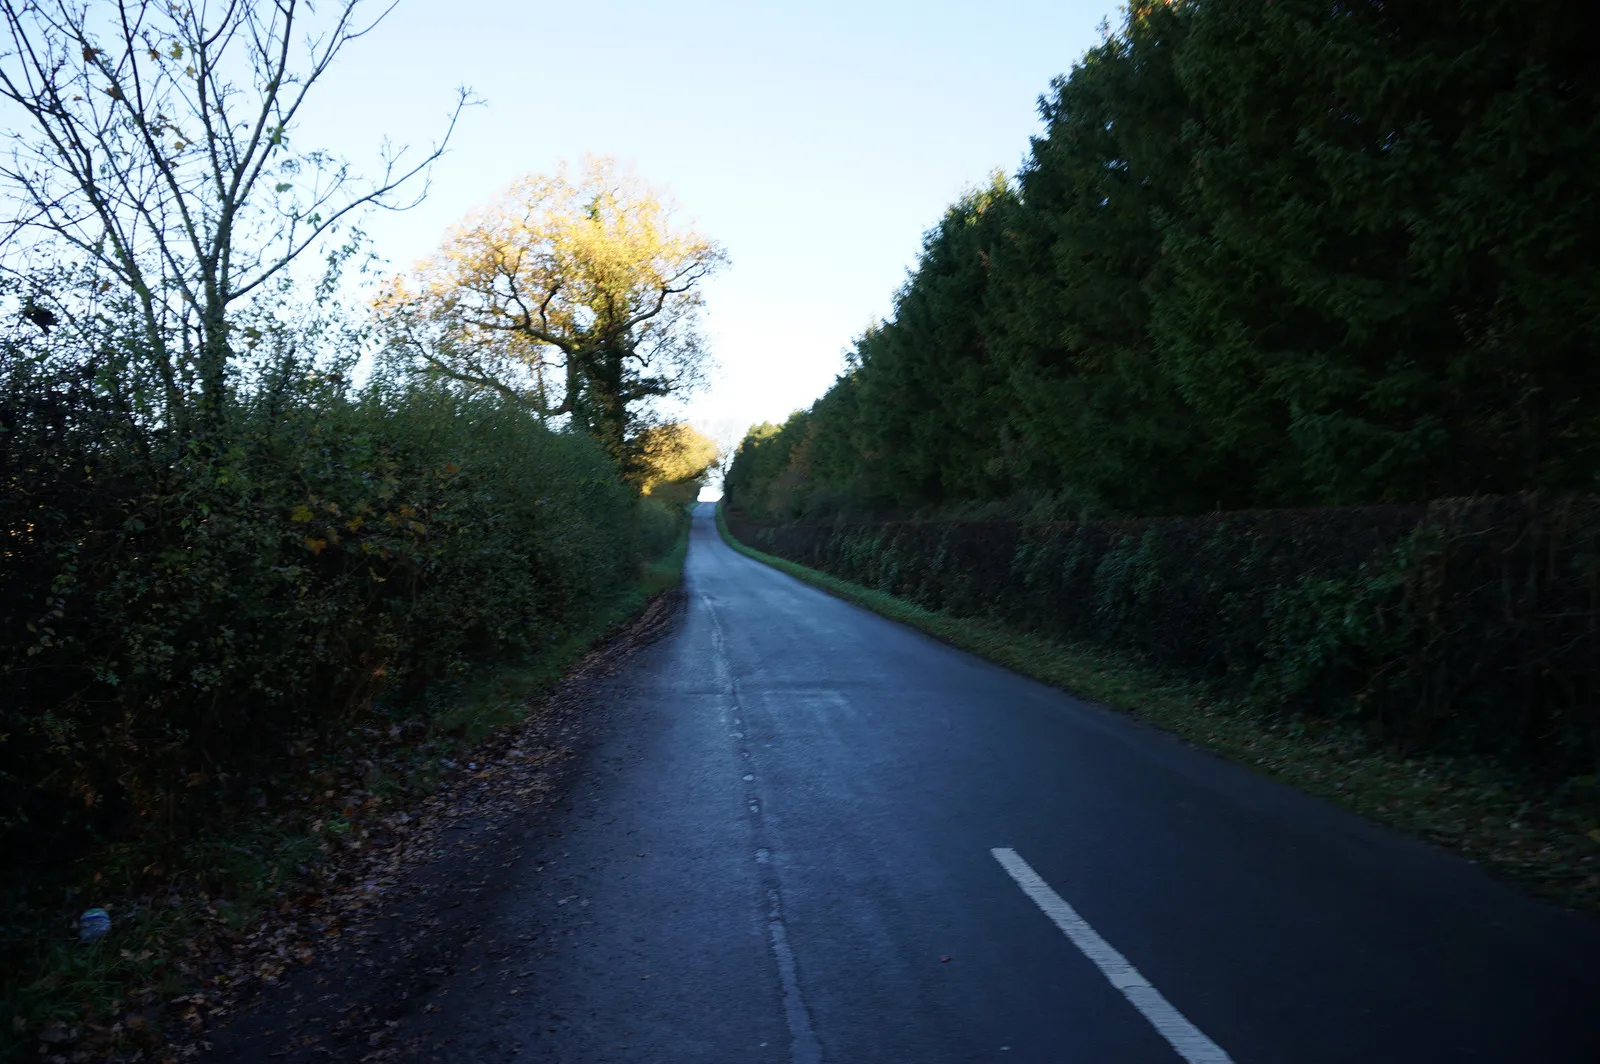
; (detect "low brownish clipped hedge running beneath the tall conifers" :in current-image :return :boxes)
[728,494,1600,778]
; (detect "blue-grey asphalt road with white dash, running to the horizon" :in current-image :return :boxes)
[416,506,1600,1064]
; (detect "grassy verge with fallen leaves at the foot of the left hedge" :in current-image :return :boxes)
[0,522,688,1059]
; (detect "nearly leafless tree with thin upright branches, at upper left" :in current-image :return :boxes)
[0,0,470,429]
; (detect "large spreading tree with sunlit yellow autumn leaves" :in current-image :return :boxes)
[381,158,726,482]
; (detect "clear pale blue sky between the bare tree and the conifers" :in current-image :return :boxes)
[296,0,1115,451]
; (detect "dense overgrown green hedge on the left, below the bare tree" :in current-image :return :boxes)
[0,344,643,877]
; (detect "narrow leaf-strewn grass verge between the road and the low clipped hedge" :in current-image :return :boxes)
[717,506,1600,914]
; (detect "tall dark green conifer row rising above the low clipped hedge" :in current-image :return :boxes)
[728,0,1600,515]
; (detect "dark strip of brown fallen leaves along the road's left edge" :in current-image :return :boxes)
[168,589,683,1062]
